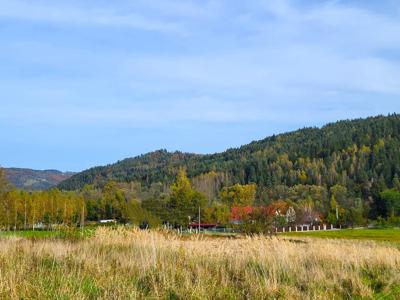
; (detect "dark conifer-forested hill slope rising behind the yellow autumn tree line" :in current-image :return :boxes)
[59,114,400,199]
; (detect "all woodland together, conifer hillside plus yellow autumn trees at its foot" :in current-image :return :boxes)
[0,115,400,233]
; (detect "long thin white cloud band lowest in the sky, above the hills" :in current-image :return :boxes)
[0,96,264,127]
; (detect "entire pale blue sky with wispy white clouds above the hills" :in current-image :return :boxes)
[0,0,400,171]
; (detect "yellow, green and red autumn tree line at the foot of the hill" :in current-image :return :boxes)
[0,168,400,232]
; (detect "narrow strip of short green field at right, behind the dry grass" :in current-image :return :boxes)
[284,229,400,244]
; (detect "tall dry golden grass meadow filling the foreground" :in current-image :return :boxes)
[0,229,400,299]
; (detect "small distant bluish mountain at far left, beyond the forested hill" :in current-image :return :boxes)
[4,168,75,191]
